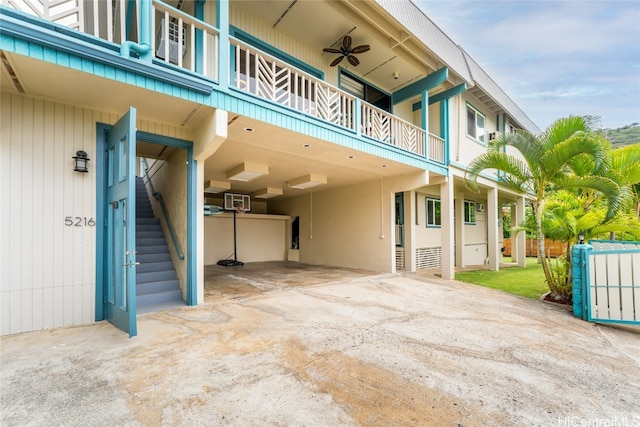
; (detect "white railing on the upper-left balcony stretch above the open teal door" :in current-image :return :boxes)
[2,0,218,79]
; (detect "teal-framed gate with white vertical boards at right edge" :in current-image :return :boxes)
[571,240,640,325]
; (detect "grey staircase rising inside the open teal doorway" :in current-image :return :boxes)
[136,177,185,314]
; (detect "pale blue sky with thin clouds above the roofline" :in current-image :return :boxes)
[414,0,640,130]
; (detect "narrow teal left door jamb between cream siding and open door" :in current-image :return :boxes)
[94,123,111,322]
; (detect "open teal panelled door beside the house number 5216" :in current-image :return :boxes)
[104,107,137,337]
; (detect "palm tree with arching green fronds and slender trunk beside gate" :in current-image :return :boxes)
[465,116,621,300]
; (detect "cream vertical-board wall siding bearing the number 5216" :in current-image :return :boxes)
[0,92,190,335]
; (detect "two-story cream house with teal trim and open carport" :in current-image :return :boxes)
[0,0,538,336]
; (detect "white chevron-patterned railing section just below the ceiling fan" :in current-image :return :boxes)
[231,39,355,130]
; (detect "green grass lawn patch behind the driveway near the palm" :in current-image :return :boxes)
[456,258,549,299]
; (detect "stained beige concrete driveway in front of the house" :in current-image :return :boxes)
[0,263,640,426]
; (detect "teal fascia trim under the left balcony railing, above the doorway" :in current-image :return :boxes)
[0,10,214,93]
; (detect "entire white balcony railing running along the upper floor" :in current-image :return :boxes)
[2,0,445,164]
